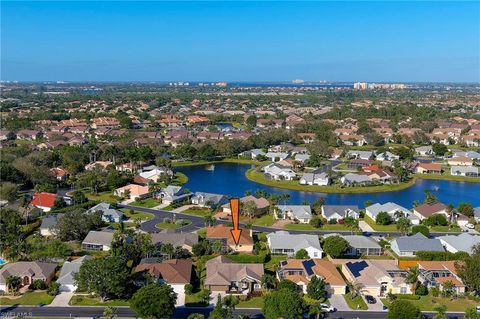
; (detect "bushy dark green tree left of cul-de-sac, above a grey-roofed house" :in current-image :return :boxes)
[53,209,103,241]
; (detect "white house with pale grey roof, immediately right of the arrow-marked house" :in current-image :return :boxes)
[267,230,323,258]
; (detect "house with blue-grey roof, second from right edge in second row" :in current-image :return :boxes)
[390,233,445,257]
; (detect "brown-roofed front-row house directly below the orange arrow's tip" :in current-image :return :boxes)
[204,256,264,295]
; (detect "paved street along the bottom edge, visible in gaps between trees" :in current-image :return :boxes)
[0,306,463,319]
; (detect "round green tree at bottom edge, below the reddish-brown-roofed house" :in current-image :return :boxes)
[130,284,177,319]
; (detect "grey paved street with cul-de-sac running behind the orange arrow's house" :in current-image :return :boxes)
[118,204,462,237]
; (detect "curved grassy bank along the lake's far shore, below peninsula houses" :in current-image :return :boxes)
[245,168,415,194]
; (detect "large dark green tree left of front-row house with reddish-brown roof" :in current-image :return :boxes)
[74,257,130,301]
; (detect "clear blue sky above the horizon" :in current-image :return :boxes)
[1,1,480,82]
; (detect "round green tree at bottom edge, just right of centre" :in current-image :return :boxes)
[262,289,306,319]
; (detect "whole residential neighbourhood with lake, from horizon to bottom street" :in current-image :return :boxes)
[0,83,480,318]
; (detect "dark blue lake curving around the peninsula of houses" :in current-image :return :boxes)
[178,163,480,208]
